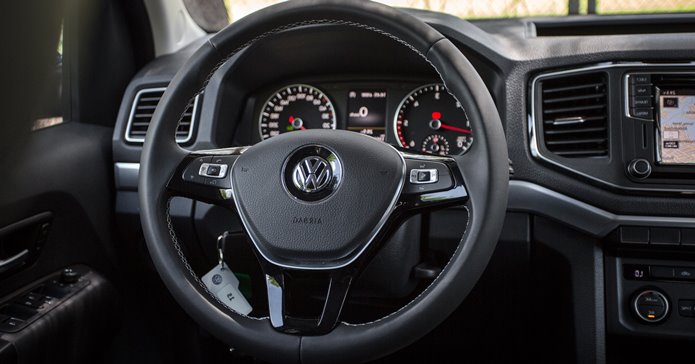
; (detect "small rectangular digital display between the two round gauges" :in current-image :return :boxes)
[347,90,386,141]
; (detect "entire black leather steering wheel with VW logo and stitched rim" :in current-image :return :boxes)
[139,0,509,363]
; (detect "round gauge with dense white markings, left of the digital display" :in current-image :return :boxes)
[259,84,335,139]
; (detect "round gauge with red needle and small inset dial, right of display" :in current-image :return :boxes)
[393,84,473,155]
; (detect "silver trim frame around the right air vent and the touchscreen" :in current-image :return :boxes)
[527,62,695,194]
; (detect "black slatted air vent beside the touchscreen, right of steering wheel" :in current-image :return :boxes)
[540,72,608,158]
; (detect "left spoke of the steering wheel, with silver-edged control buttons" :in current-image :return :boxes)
[166,147,247,207]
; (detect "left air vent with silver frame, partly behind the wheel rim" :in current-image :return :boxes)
[125,87,199,143]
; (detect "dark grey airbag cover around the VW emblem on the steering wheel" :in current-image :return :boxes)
[232,130,404,267]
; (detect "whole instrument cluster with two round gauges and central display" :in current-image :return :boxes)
[255,82,473,155]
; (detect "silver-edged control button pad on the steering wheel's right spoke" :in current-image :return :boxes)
[403,159,454,194]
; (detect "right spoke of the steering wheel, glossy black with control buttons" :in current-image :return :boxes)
[399,152,468,213]
